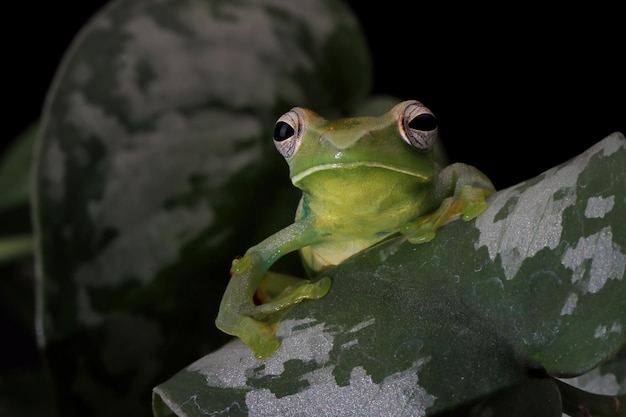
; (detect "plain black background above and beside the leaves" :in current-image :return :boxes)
[2,0,626,188]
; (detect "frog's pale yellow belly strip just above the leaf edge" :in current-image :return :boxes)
[300,236,387,273]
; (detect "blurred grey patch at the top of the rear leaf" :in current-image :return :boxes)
[118,1,320,119]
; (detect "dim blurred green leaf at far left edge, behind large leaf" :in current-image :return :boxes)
[0,125,38,213]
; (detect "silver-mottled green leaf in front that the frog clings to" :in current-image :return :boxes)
[154,133,626,416]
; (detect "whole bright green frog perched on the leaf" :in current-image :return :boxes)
[216,100,495,358]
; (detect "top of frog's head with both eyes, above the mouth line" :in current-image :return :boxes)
[274,100,437,188]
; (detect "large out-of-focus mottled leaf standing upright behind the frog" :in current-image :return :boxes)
[34,0,370,416]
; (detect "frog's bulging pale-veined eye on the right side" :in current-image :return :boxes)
[398,101,437,150]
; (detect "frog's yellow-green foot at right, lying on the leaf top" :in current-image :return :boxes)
[402,185,493,244]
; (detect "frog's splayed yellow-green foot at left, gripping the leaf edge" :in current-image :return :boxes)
[215,255,331,359]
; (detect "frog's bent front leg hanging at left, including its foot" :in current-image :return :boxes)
[215,222,330,359]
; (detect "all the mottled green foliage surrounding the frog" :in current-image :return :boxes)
[0,0,626,417]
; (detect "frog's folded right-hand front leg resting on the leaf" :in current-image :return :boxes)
[402,163,495,243]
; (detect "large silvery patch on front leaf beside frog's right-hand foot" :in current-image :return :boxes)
[475,135,625,279]
